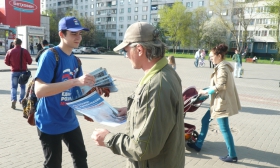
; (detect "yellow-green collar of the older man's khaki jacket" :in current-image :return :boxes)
[139,57,168,86]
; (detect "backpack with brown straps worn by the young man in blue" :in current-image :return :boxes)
[21,48,82,126]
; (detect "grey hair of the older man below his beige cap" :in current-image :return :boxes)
[129,39,166,61]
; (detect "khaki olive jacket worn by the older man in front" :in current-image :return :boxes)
[104,58,185,168]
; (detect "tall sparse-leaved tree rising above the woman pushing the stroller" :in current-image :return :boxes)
[210,0,257,52]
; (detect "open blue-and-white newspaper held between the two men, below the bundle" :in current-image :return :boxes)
[66,91,126,127]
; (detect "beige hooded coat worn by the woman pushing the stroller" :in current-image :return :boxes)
[210,61,241,118]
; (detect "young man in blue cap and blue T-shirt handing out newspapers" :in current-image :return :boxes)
[35,17,95,168]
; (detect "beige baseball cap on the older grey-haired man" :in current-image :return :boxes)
[114,22,158,52]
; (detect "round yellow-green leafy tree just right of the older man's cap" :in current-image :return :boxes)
[158,2,189,53]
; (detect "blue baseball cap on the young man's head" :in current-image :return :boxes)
[58,16,89,32]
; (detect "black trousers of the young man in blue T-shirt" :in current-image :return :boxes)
[37,127,88,168]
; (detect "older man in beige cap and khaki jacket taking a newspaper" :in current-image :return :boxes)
[92,22,185,168]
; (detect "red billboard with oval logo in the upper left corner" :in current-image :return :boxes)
[0,0,41,28]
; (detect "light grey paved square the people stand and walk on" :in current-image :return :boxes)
[0,55,280,168]
